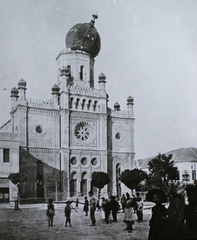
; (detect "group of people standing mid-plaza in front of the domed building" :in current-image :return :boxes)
[46,192,143,232]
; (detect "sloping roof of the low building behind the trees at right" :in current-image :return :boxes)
[136,148,197,169]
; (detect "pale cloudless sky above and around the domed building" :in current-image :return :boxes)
[0,0,197,159]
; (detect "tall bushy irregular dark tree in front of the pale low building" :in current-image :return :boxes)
[147,153,179,188]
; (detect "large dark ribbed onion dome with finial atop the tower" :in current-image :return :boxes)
[66,15,101,58]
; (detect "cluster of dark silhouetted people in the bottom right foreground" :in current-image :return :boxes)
[146,186,197,240]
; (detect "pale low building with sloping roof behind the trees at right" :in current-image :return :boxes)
[136,148,197,184]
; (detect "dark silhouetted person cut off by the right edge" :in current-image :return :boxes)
[185,185,197,239]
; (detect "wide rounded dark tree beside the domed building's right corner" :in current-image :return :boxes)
[120,168,147,191]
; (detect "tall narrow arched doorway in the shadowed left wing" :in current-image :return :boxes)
[36,160,44,198]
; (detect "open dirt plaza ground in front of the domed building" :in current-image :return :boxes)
[0,203,151,240]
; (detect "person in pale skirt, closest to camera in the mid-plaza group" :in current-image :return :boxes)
[123,192,134,232]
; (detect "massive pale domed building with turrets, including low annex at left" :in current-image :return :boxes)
[0,15,135,200]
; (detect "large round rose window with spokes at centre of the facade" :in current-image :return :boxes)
[74,122,92,142]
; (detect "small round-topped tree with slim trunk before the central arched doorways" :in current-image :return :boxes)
[92,172,110,199]
